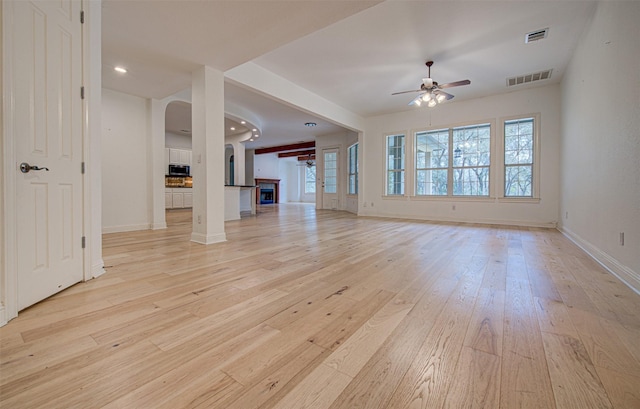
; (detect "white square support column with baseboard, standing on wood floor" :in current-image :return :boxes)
[191,67,226,244]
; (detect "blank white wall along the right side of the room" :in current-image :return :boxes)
[560,2,640,292]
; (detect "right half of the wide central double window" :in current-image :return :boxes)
[453,124,491,196]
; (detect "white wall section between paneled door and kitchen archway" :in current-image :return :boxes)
[101,89,151,233]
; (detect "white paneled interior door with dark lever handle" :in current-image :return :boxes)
[10,0,83,310]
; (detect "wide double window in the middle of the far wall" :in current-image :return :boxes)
[415,124,491,196]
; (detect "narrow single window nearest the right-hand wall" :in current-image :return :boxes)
[504,118,534,197]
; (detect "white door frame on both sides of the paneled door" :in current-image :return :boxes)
[0,0,104,326]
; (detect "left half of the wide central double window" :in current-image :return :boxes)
[416,129,449,196]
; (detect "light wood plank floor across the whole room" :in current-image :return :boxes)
[0,205,640,409]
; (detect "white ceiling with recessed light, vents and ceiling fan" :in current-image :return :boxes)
[102,0,595,148]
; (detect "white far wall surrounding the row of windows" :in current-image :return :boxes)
[358,85,561,227]
